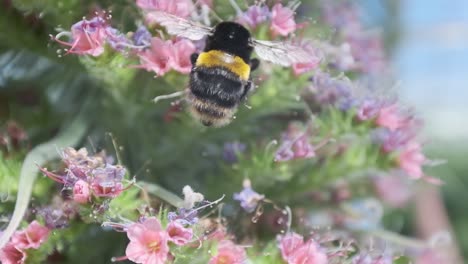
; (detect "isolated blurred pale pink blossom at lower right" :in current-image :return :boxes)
[373,175,411,208]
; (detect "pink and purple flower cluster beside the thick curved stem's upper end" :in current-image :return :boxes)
[41,148,126,204]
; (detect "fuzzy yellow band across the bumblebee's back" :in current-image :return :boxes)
[196,50,250,80]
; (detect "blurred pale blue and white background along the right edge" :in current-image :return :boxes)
[359,0,468,259]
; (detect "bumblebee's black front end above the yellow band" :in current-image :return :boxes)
[205,22,253,63]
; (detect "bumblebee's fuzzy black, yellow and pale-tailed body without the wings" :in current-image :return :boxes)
[187,22,258,126]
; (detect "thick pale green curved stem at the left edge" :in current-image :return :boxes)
[0,114,87,248]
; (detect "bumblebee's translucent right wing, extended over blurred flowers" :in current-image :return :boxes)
[252,40,319,66]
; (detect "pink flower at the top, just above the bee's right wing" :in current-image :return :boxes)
[270,3,296,36]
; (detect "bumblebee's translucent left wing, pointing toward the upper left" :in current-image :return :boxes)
[146,11,212,40]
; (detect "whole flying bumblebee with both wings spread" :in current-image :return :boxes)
[149,12,313,127]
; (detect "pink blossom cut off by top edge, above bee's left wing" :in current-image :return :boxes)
[136,0,193,18]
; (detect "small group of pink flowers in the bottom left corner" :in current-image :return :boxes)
[0,221,50,264]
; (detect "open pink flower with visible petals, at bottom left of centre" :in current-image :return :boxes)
[125,217,169,264]
